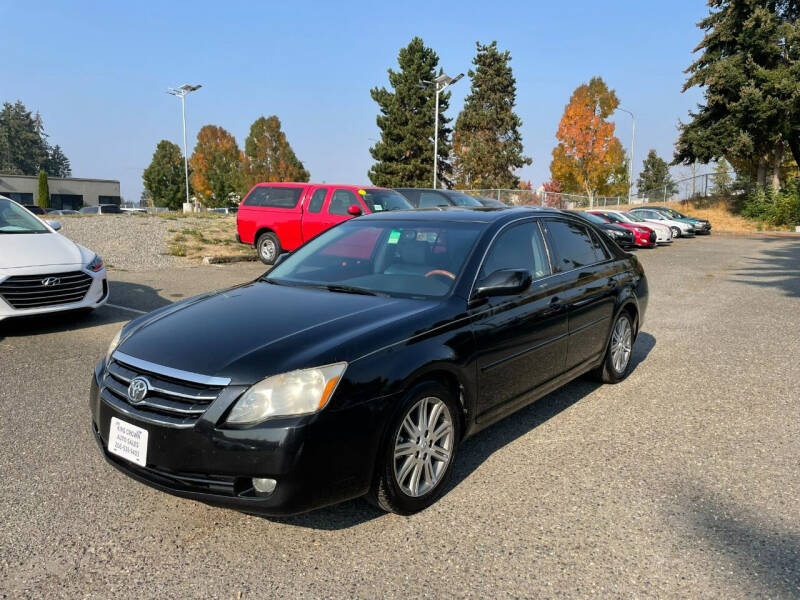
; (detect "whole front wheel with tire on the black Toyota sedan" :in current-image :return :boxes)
[369,382,461,515]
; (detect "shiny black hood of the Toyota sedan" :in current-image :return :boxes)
[117,280,442,384]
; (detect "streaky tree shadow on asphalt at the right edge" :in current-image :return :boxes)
[732,237,800,298]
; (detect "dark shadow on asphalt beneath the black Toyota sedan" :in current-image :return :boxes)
[264,331,656,530]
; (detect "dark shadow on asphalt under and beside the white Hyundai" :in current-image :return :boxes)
[0,281,170,342]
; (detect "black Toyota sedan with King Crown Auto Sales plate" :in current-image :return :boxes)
[90,208,648,514]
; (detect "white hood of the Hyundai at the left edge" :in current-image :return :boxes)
[0,233,91,270]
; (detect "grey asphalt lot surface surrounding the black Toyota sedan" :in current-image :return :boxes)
[0,236,800,599]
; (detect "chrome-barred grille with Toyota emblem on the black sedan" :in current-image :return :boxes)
[103,355,224,427]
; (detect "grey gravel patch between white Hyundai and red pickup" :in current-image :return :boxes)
[59,215,236,271]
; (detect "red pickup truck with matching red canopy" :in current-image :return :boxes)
[236,182,413,265]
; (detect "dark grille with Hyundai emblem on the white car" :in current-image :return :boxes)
[0,271,92,309]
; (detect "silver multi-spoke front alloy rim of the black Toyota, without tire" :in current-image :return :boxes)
[394,396,454,497]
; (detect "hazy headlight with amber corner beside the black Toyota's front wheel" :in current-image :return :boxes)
[226,362,347,425]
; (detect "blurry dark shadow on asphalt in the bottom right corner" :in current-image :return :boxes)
[680,486,800,598]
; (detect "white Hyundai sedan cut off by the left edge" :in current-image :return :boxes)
[0,196,108,321]
